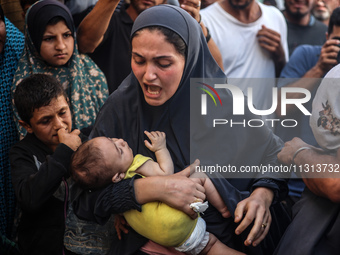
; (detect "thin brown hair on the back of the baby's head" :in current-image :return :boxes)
[71,140,112,189]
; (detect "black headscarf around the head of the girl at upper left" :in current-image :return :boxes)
[26,0,75,52]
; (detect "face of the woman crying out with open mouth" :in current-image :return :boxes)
[131,29,185,106]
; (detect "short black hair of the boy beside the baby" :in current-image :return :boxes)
[13,74,68,124]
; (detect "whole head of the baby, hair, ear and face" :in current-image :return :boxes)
[71,137,133,189]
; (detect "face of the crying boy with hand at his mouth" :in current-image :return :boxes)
[24,95,72,151]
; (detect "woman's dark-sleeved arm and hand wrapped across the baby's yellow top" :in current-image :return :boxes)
[72,163,205,224]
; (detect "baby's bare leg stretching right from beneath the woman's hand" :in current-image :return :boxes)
[190,173,231,218]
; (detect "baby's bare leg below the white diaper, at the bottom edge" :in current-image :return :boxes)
[200,233,244,255]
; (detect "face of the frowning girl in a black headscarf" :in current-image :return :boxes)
[40,21,74,66]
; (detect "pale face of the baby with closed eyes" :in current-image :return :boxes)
[96,137,133,175]
